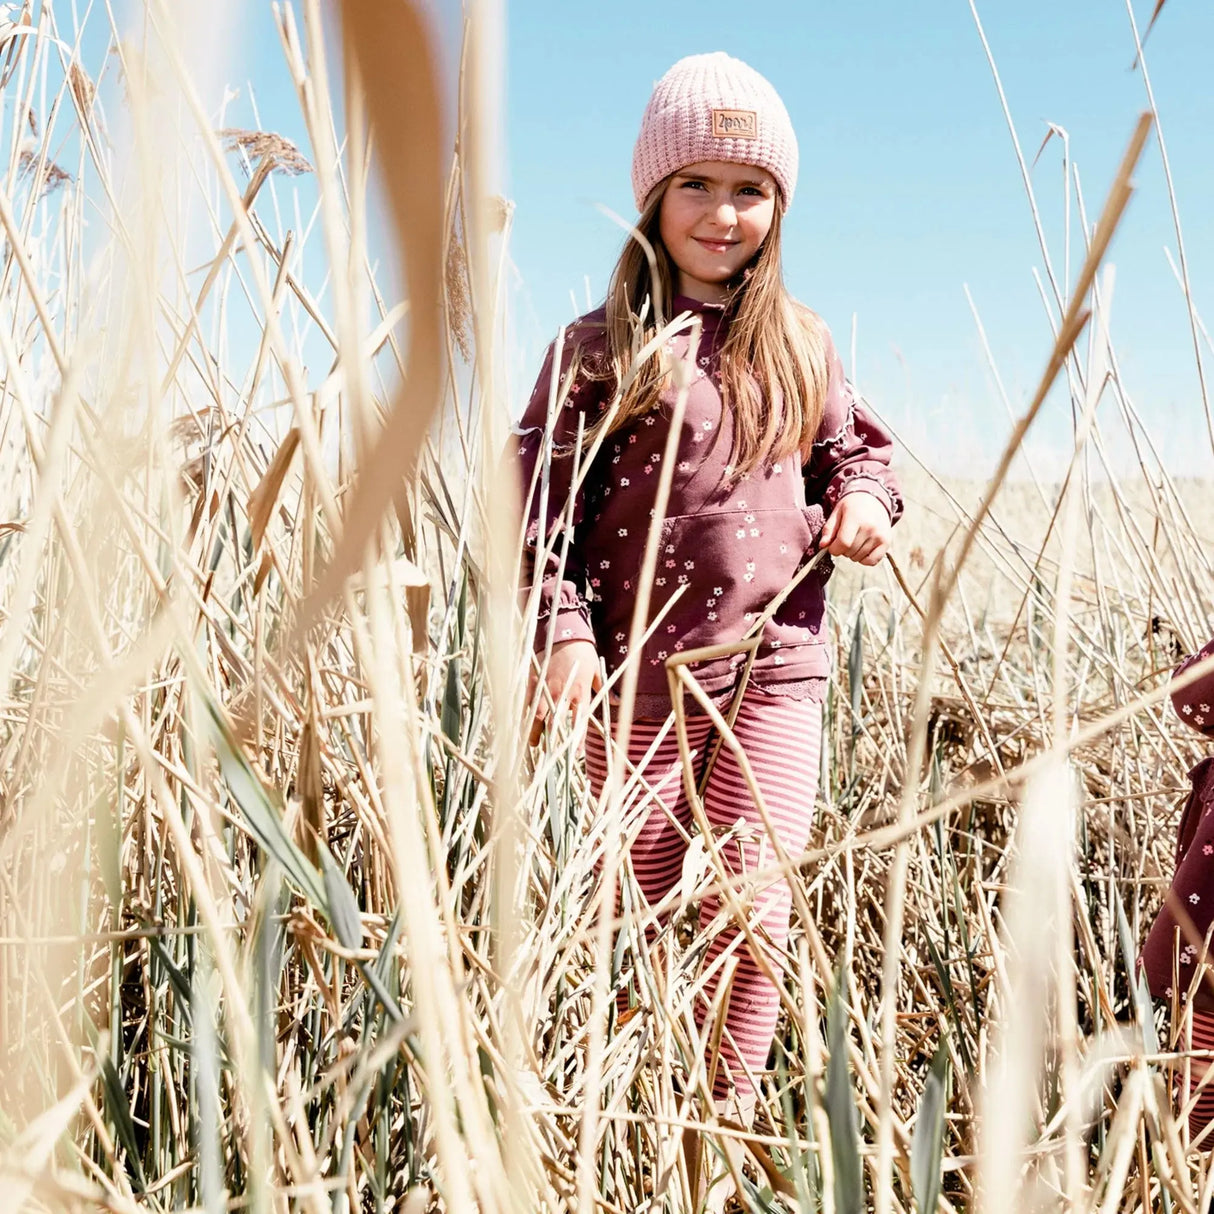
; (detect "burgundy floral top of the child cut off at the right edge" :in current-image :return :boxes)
[1141,641,1214,1011]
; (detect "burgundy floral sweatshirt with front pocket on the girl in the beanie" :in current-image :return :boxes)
[516,296,902,715]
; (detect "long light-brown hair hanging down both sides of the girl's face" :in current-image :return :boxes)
[583,183,829,477]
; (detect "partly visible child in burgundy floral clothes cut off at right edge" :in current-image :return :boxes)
[1142,641,1214,1151]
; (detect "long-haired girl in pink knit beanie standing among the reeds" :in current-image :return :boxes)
[517,53,902,1204]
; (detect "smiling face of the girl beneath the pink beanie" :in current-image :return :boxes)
[658,160,778,304]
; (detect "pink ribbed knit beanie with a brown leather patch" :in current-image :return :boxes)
[632,51,796,211]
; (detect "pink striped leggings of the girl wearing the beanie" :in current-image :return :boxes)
[586,691,822,1097]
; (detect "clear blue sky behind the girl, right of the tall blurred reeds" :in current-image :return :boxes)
[505,0,1214,471]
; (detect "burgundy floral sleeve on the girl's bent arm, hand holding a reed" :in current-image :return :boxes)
[804,331,902,522]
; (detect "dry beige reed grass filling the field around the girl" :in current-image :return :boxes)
[0,0,1214,1214]
